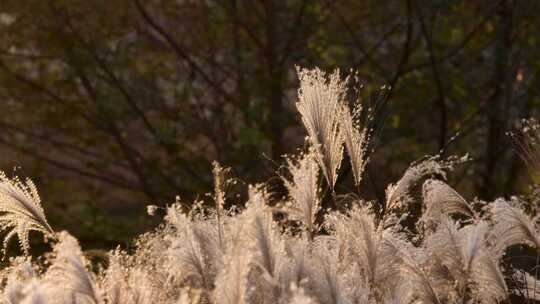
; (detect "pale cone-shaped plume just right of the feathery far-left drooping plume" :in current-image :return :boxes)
[42,231,100,304]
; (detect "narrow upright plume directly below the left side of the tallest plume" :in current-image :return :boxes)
[282,151,321,239]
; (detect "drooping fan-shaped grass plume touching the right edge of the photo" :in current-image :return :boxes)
[491,199,540,257]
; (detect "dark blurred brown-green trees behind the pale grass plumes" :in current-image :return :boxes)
[0,0,540,247]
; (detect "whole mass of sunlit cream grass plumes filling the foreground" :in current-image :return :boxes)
[0,69,540,304]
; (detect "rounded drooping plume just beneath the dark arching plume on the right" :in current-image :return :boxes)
[421,179,476,226]
